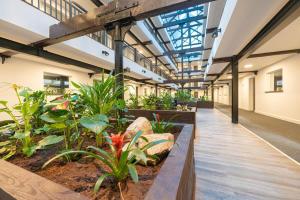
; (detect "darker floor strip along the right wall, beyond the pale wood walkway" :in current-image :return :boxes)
[215,104,300,163]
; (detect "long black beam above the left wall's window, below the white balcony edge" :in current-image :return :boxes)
[0,37,110,73]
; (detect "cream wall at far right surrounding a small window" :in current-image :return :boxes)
[255,55,300,124]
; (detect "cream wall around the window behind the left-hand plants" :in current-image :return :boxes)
[0,57,96,121]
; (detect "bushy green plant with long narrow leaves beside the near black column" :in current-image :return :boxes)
[72,76,124,116]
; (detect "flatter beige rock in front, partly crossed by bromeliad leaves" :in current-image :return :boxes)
[138,133,174,155]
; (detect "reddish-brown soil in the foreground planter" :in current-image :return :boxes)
[9,127,181,200]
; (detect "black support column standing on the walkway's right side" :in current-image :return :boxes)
[230,56,239,124]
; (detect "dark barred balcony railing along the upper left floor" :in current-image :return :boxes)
[22,0,170,79]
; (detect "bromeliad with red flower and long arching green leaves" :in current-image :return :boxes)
[43,131,168,199]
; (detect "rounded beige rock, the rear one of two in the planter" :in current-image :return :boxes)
[126,117,153,136]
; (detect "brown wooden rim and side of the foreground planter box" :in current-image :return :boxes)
[0,124,196,200]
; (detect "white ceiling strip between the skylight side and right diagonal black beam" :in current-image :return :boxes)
[215,0,288,57]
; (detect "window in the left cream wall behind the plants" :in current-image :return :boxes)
[44,73,69,95]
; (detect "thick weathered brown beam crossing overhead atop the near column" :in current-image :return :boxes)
[39,0,215,46]
